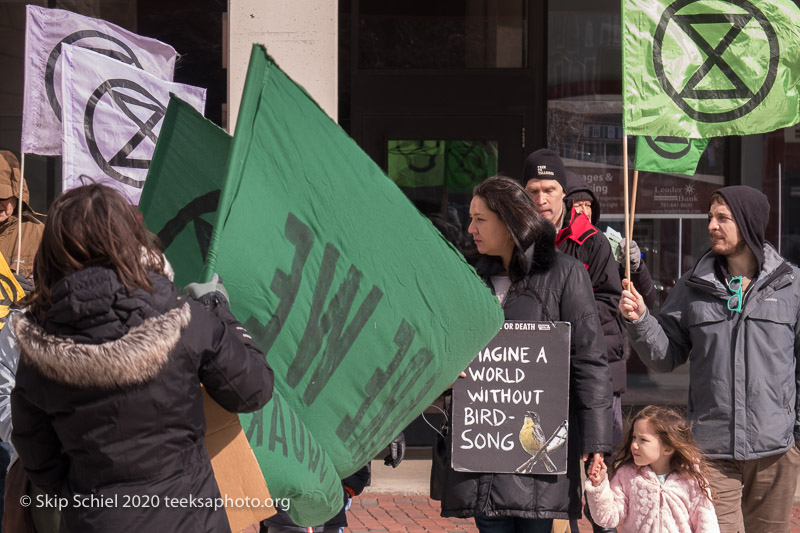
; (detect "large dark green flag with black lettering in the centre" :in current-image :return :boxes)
[204,46,503,477]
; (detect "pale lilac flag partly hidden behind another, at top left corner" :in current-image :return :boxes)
[22,5,177,155]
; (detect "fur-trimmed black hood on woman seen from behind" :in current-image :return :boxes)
[13,267,191,388]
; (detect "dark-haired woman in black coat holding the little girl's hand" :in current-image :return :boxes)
[441,176,612,533]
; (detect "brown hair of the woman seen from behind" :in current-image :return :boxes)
[30,184,164,318]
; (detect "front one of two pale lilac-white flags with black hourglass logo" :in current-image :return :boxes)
[60,45,206,204]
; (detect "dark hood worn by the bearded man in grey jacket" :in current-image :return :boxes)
[709,185,769,272]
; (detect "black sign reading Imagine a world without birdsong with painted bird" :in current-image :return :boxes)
[451,320,571,474]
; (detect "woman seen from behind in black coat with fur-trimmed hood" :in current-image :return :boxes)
[11,184,272,533]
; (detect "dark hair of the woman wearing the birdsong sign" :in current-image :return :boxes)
[472,176,550,281]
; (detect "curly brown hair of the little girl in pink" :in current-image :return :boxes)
[608,405,713,499]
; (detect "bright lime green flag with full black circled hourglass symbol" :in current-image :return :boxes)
[622,0,800,138]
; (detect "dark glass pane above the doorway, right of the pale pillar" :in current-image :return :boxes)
[357,0,528,69]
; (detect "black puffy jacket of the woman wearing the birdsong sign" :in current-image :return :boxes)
[432,226,612,519]
